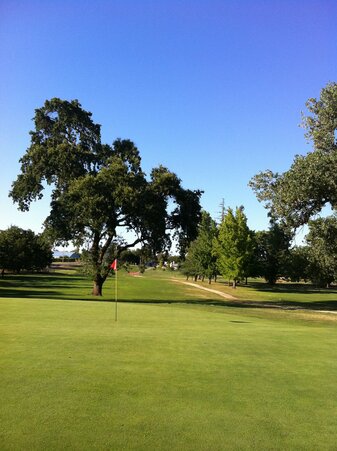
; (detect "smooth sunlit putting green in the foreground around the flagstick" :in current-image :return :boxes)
[0,278,337,450]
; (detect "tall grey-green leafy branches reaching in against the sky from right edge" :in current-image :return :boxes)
[250,83,337,228]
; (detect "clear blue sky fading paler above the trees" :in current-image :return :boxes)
[0,0,337,240]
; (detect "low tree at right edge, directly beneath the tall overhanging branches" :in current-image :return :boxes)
[306,216,337,287]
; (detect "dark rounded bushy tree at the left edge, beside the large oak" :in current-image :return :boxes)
[0,226,53,277]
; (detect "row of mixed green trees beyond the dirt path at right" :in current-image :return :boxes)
[182,207,337,287]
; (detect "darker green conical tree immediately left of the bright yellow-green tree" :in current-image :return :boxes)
[183,211,217,283]
